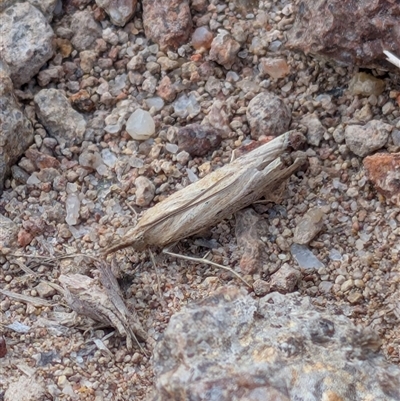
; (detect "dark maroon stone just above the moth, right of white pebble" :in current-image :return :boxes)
[178,124,221,156]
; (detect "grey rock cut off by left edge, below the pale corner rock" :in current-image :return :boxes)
[0,60,33,193]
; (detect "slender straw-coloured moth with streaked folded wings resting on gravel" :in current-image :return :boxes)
[104,131,304,255]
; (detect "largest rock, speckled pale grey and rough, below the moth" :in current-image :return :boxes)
[153,287,400,401]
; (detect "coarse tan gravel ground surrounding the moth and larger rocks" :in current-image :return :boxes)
[0,0,400,401]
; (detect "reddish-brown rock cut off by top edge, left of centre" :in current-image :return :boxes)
[142,0,193,50]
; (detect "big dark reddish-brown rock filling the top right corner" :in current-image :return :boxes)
[286,0,400,70]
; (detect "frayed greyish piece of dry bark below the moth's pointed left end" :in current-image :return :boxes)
[59,262,147,349]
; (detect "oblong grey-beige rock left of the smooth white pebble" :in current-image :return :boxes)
[34,89,86,147]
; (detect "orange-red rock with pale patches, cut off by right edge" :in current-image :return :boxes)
[363,153,400,206]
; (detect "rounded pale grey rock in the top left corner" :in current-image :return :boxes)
[0,3,55,87]
